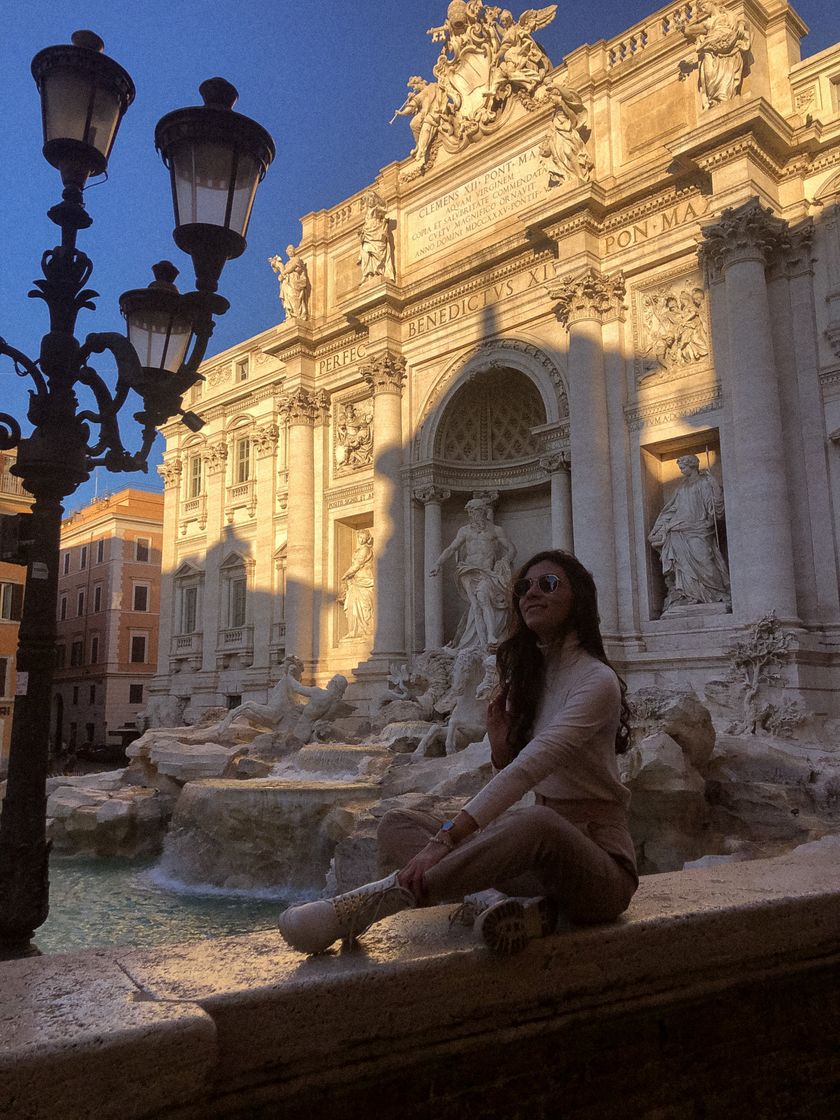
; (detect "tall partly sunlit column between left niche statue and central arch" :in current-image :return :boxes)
[360,351,405,659]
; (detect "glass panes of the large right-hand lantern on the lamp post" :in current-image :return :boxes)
[171,140,260,236]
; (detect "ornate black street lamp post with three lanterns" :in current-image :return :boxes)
[0,31,274,959]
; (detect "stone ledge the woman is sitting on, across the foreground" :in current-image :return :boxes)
[0,838,840,1120]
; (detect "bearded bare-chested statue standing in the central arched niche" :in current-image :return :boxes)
[429,498,516,651]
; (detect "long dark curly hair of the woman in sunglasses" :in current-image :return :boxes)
[496,549,631,756]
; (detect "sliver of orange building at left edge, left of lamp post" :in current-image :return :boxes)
[0,451,34,777]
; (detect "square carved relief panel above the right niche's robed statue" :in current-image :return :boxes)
[642,287,709,377]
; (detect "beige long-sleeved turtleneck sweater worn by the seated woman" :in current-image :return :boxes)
[464,634,632,833]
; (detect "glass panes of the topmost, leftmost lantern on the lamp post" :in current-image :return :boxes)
[43,67,120,157]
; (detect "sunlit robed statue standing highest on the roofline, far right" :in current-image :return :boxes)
[675,0,752,109]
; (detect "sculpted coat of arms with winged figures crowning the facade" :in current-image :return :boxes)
[391,0,557,179]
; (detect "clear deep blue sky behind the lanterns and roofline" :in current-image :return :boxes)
[0,0,840,510]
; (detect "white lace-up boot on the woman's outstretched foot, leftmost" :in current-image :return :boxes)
[278,871,417,953]
